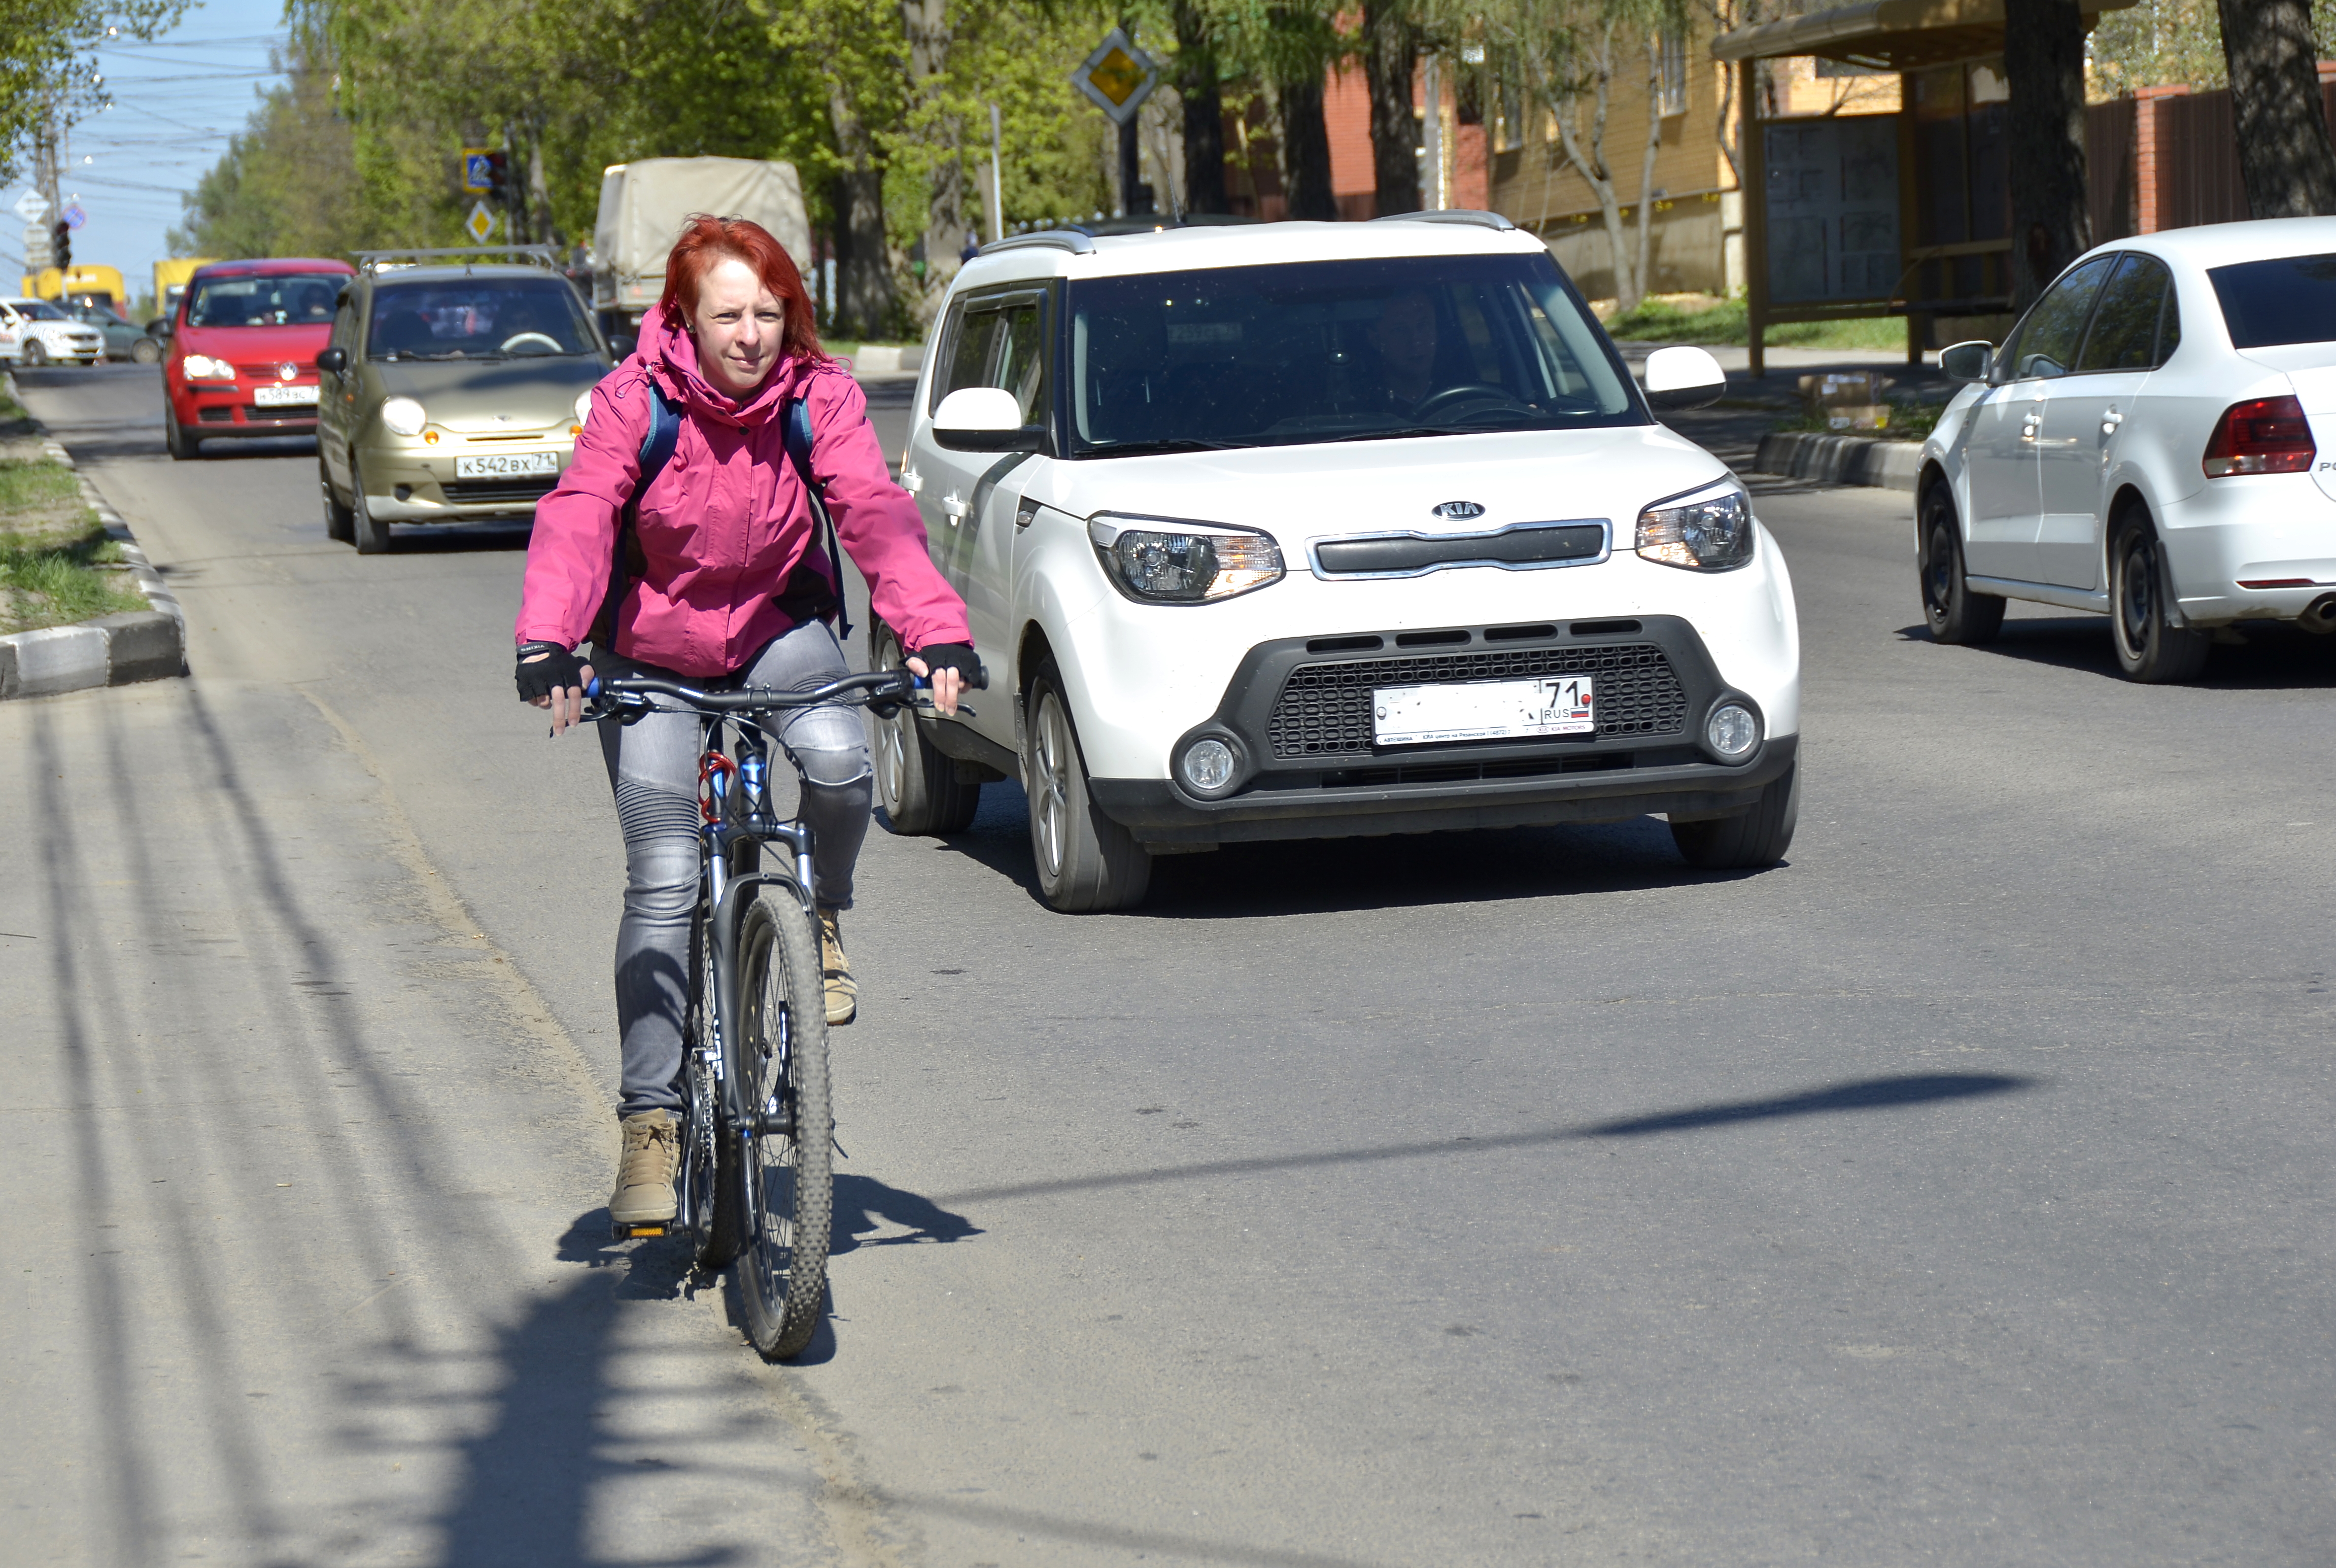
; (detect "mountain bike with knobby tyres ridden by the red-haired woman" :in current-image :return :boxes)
[584,668,988,1360]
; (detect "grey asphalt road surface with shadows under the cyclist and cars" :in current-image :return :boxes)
[0,369,2336,1568]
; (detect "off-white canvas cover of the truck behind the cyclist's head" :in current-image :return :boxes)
[593,159,811,313]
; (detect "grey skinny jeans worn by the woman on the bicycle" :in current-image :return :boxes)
[591,621,871,1117]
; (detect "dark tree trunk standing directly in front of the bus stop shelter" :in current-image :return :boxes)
[2004,0,2093,311]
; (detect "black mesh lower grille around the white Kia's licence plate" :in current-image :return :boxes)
[1266,643,1687,759]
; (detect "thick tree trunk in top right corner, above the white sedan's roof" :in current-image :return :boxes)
[2217,0,2336,217]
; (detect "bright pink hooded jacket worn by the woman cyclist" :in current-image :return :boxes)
[516,311,974,675]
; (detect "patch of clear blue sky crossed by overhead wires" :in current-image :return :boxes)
[0,0,285,306]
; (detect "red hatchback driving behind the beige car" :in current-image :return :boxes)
[161,257,357,458]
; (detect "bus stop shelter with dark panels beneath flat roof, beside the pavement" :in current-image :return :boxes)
[1712,0,2135,376]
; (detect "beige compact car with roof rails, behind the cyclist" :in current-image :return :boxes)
[316,253,614,556]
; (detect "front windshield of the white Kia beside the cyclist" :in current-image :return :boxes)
[1068,255,1644,456]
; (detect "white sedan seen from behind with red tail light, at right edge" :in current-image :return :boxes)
[1915,217,2336,680]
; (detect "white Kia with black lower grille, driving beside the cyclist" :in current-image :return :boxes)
[871,213,1801,909]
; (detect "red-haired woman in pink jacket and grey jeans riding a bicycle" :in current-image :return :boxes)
[516,217,979,1225]
